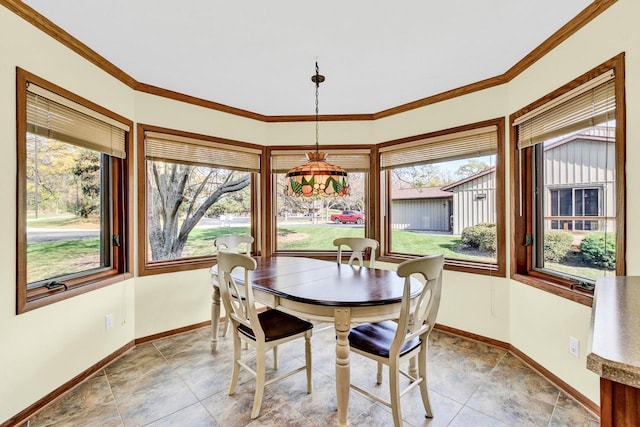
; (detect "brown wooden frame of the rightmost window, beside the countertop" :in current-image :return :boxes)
[509,53,626,306]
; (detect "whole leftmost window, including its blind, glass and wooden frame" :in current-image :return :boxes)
[17,69,131,313]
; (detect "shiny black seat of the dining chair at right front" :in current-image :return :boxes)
[349,320,421,358]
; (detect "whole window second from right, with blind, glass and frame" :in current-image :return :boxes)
[379,119,504,274]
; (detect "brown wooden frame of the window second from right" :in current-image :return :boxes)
[372,117,506,277]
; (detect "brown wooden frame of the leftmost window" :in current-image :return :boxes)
[16,67,133,314]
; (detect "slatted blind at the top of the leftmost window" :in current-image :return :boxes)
[27,83,129,158]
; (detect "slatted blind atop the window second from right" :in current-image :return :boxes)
[380,126,498,169]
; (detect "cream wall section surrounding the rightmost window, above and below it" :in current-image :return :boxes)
[507,0,640,402]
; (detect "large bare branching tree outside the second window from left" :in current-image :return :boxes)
[147,161,251,261]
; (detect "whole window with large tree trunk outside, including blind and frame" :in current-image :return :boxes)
[138,125,262,275]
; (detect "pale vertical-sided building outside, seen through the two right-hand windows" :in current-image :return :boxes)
[391,126,616,235]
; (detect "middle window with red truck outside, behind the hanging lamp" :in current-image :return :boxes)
[271,148,371,253]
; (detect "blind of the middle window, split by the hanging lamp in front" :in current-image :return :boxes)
[271,149,370,173]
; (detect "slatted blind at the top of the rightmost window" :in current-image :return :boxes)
[513,70,616,149]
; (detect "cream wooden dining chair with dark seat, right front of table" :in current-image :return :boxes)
[349,255,444,426]
